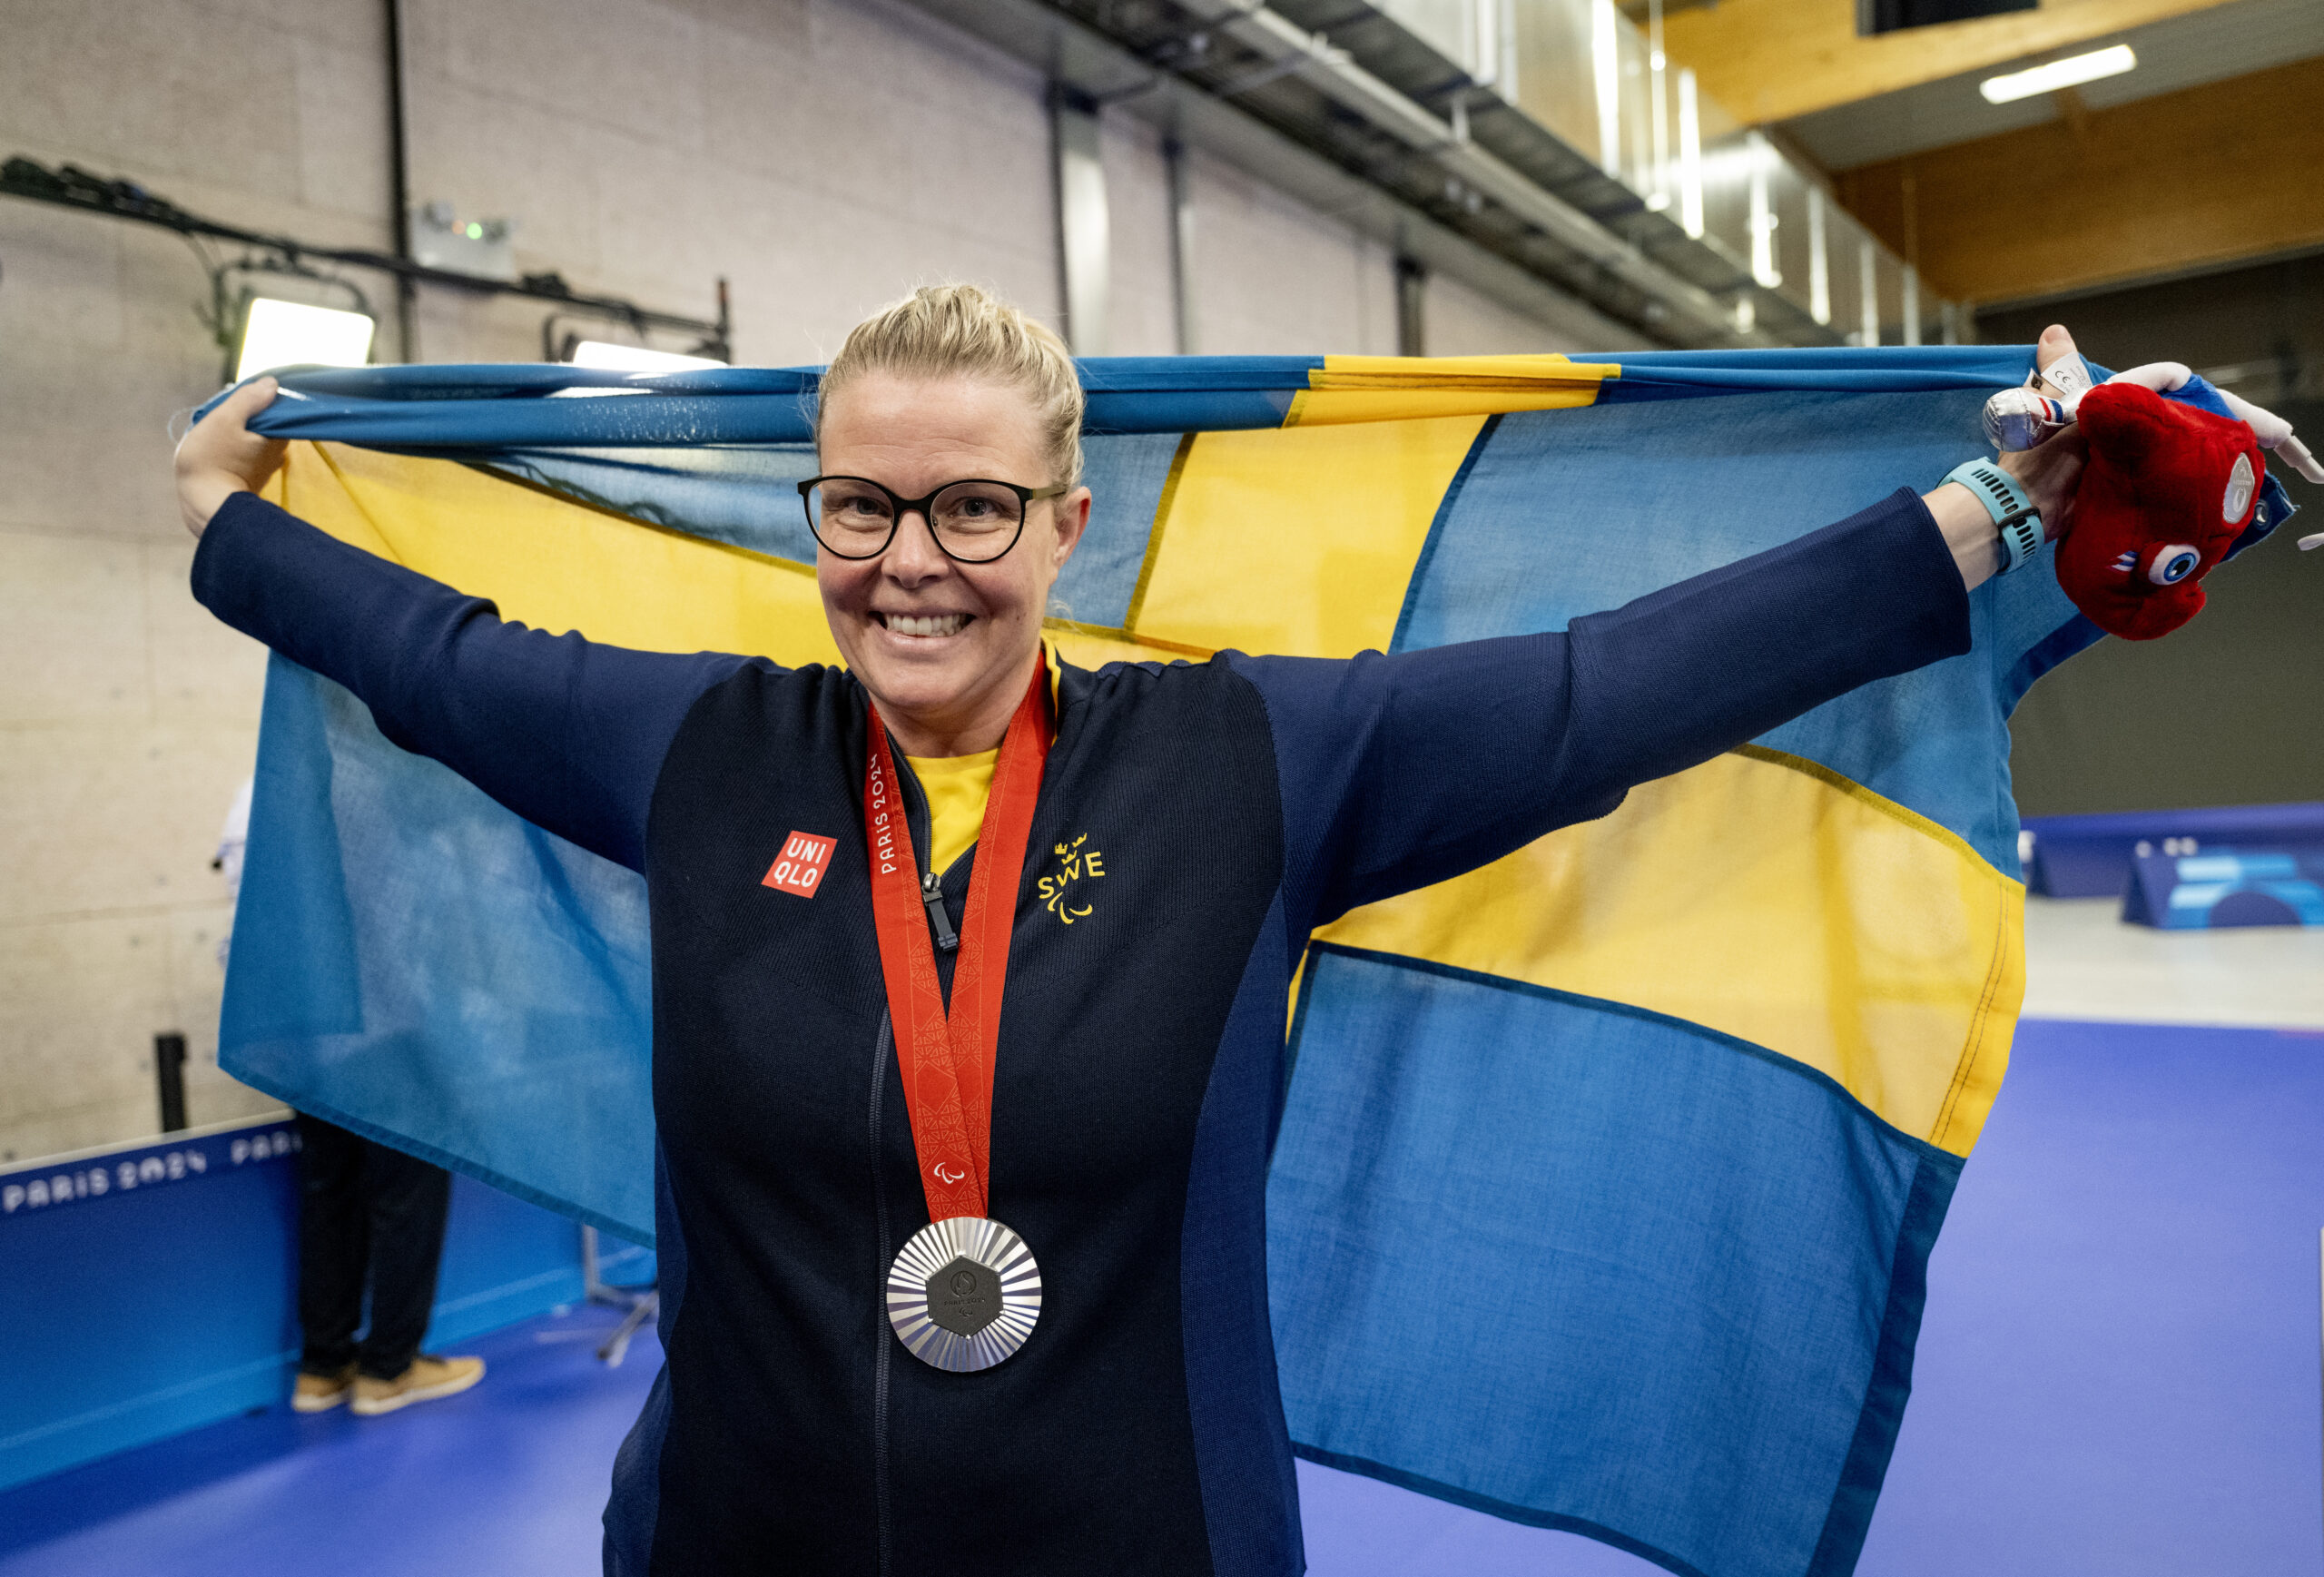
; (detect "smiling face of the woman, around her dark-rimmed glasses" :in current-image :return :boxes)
[816,371,1090,754]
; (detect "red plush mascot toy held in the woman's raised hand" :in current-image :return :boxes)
[1984,355,2324,641]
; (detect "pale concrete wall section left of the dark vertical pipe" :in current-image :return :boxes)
[0,0,386,1159]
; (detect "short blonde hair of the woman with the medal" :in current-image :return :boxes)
[816,286,1080,488]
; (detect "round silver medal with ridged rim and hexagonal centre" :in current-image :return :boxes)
[888,1215,1041,1375]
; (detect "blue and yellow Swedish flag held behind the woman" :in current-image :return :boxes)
[221,346,2291,1577]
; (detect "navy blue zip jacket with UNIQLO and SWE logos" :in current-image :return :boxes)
[192,492,1971,1577]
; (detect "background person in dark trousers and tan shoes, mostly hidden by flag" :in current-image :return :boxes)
[212,781,483,1416]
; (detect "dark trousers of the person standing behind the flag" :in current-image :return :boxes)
[298,1112,451,1380]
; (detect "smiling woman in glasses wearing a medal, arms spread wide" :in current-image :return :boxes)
[179,286,2080,1574]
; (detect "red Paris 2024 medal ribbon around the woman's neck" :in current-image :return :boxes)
[864,657,1049,1222]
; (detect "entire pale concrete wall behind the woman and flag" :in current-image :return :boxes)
[0,0,1608,1161]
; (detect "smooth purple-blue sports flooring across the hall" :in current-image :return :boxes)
[0,1022,2324,1577]
